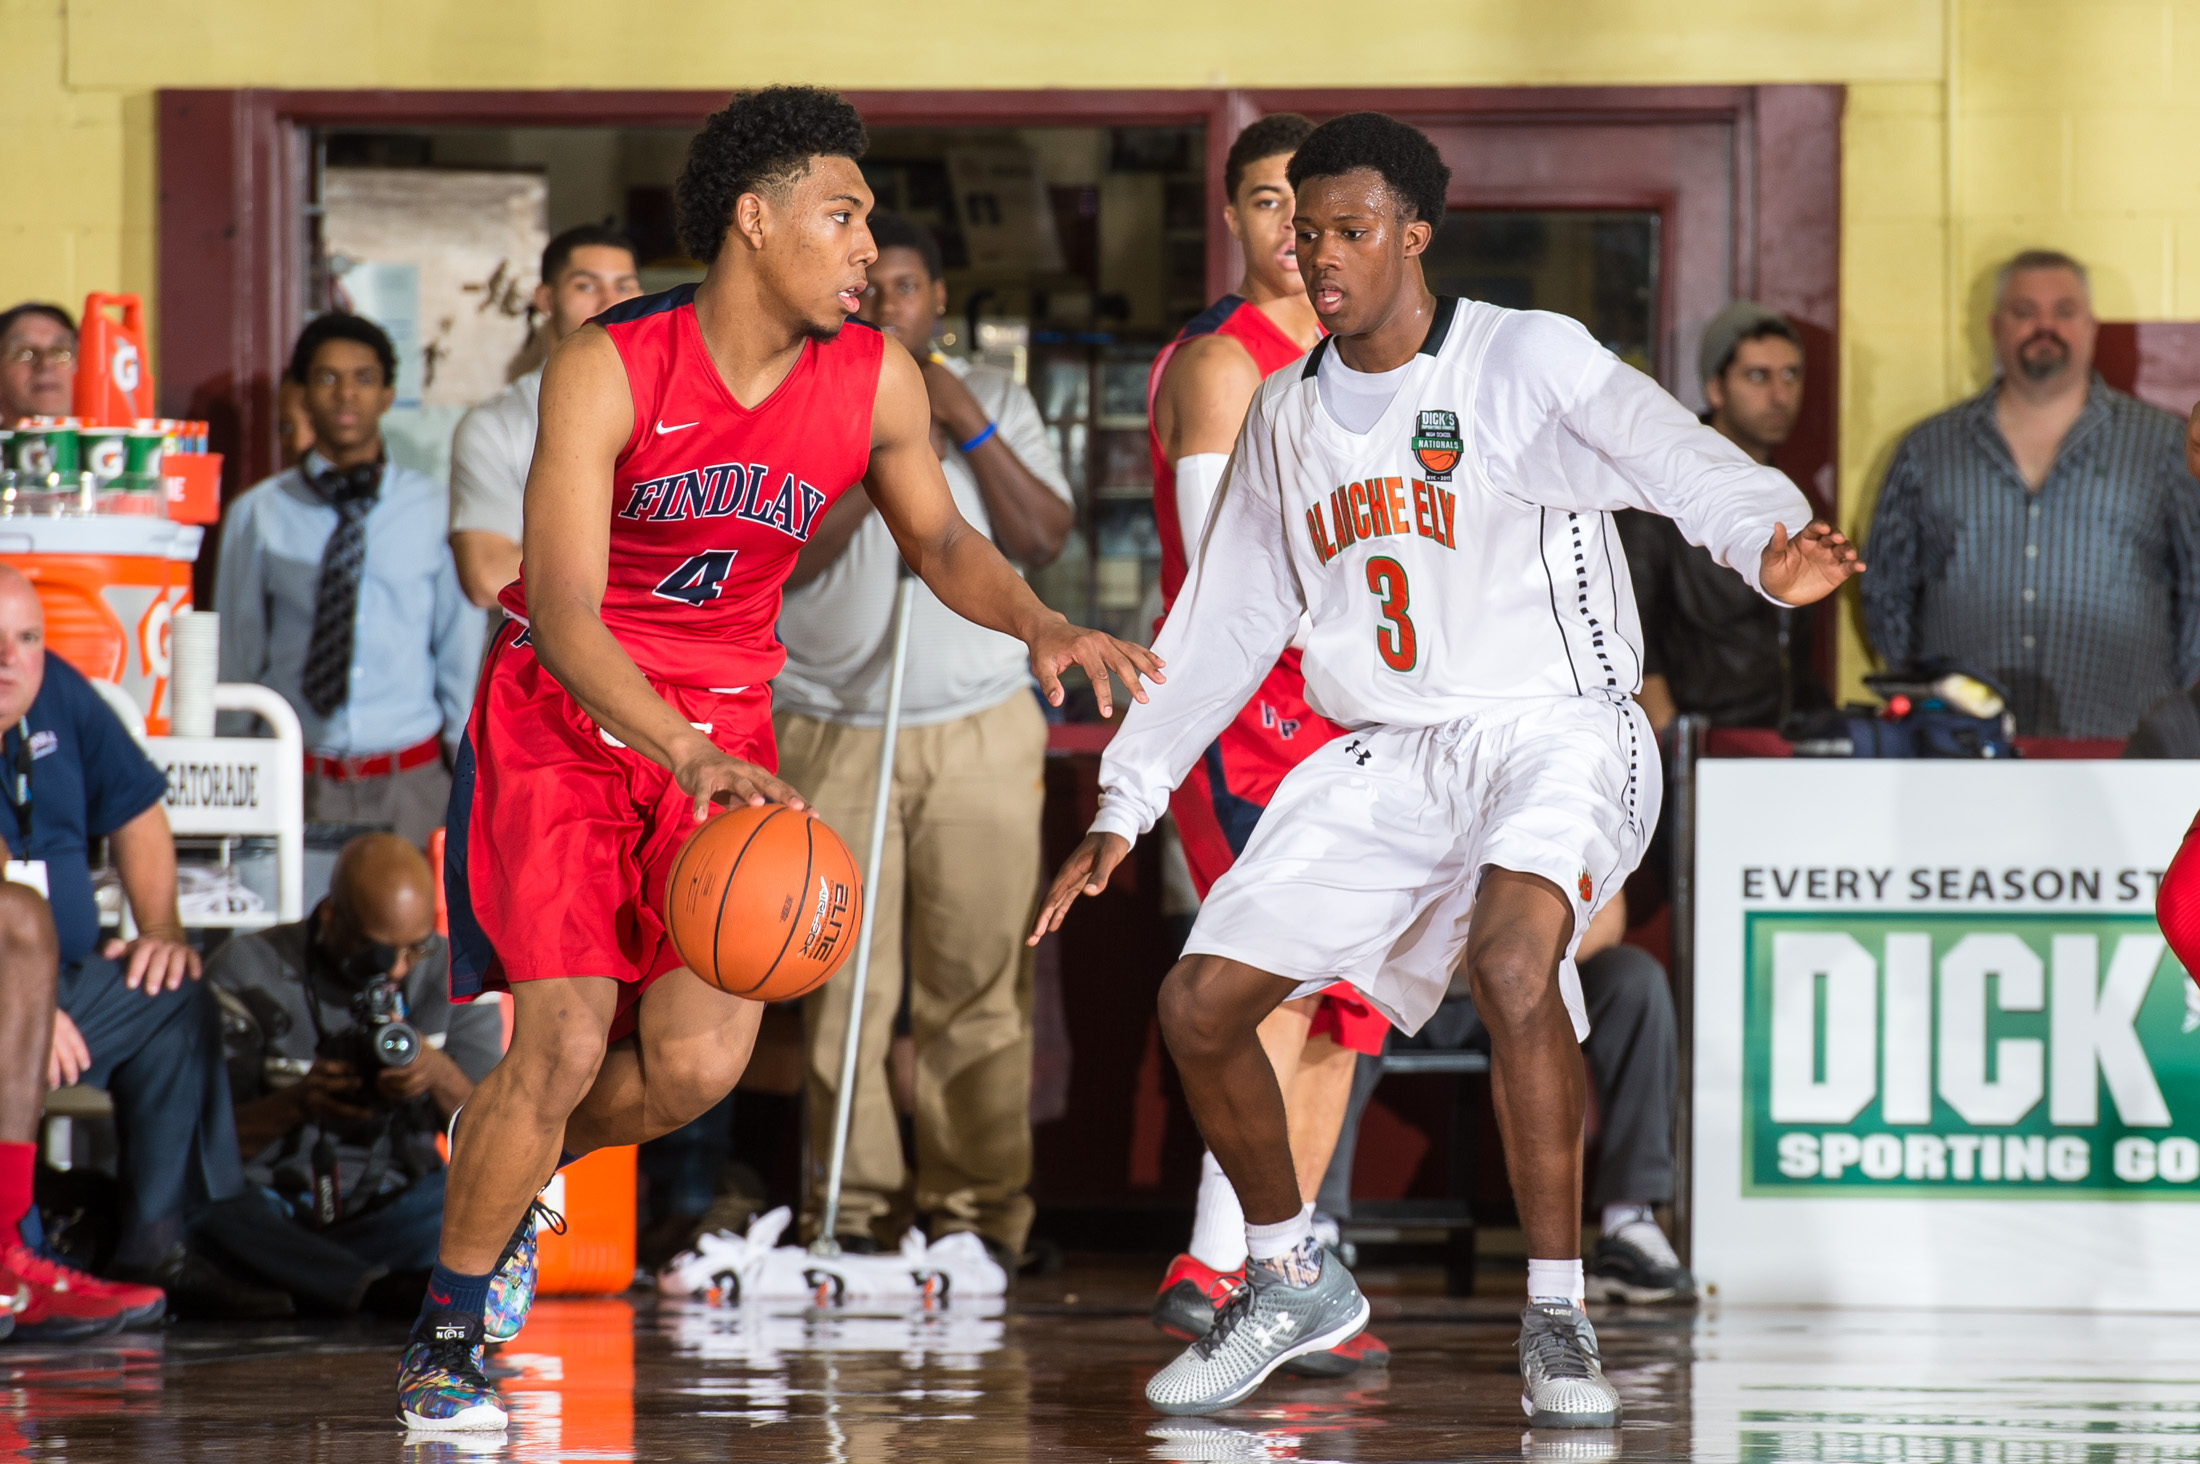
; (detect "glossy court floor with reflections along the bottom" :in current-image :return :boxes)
[0,1264,2200,1464]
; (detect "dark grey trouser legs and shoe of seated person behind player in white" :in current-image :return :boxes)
[1320,896,1696,1303]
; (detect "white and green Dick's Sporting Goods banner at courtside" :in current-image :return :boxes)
[1694,760,2200,1310]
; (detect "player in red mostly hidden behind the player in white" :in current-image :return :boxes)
[1146,112,1388,1376]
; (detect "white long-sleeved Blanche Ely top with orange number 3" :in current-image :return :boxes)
[1093,299,1811,839]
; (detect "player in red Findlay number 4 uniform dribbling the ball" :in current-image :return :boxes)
[398,88,1159,1429]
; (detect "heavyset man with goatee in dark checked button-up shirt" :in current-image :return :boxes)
[1863,249,2200,738]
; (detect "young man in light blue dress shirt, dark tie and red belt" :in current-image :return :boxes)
[213,315,482,843]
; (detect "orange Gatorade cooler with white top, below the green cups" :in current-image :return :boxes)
[0,519,199,735]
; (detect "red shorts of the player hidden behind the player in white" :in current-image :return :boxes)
[1168,652,1390,1057]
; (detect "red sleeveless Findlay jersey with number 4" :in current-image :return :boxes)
[497,284,887,687]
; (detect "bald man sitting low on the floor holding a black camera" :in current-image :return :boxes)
[207,834,504,1314]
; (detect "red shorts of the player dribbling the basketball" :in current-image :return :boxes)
[442,623,779,1039]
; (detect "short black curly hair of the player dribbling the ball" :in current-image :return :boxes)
[673,86,867,264]
